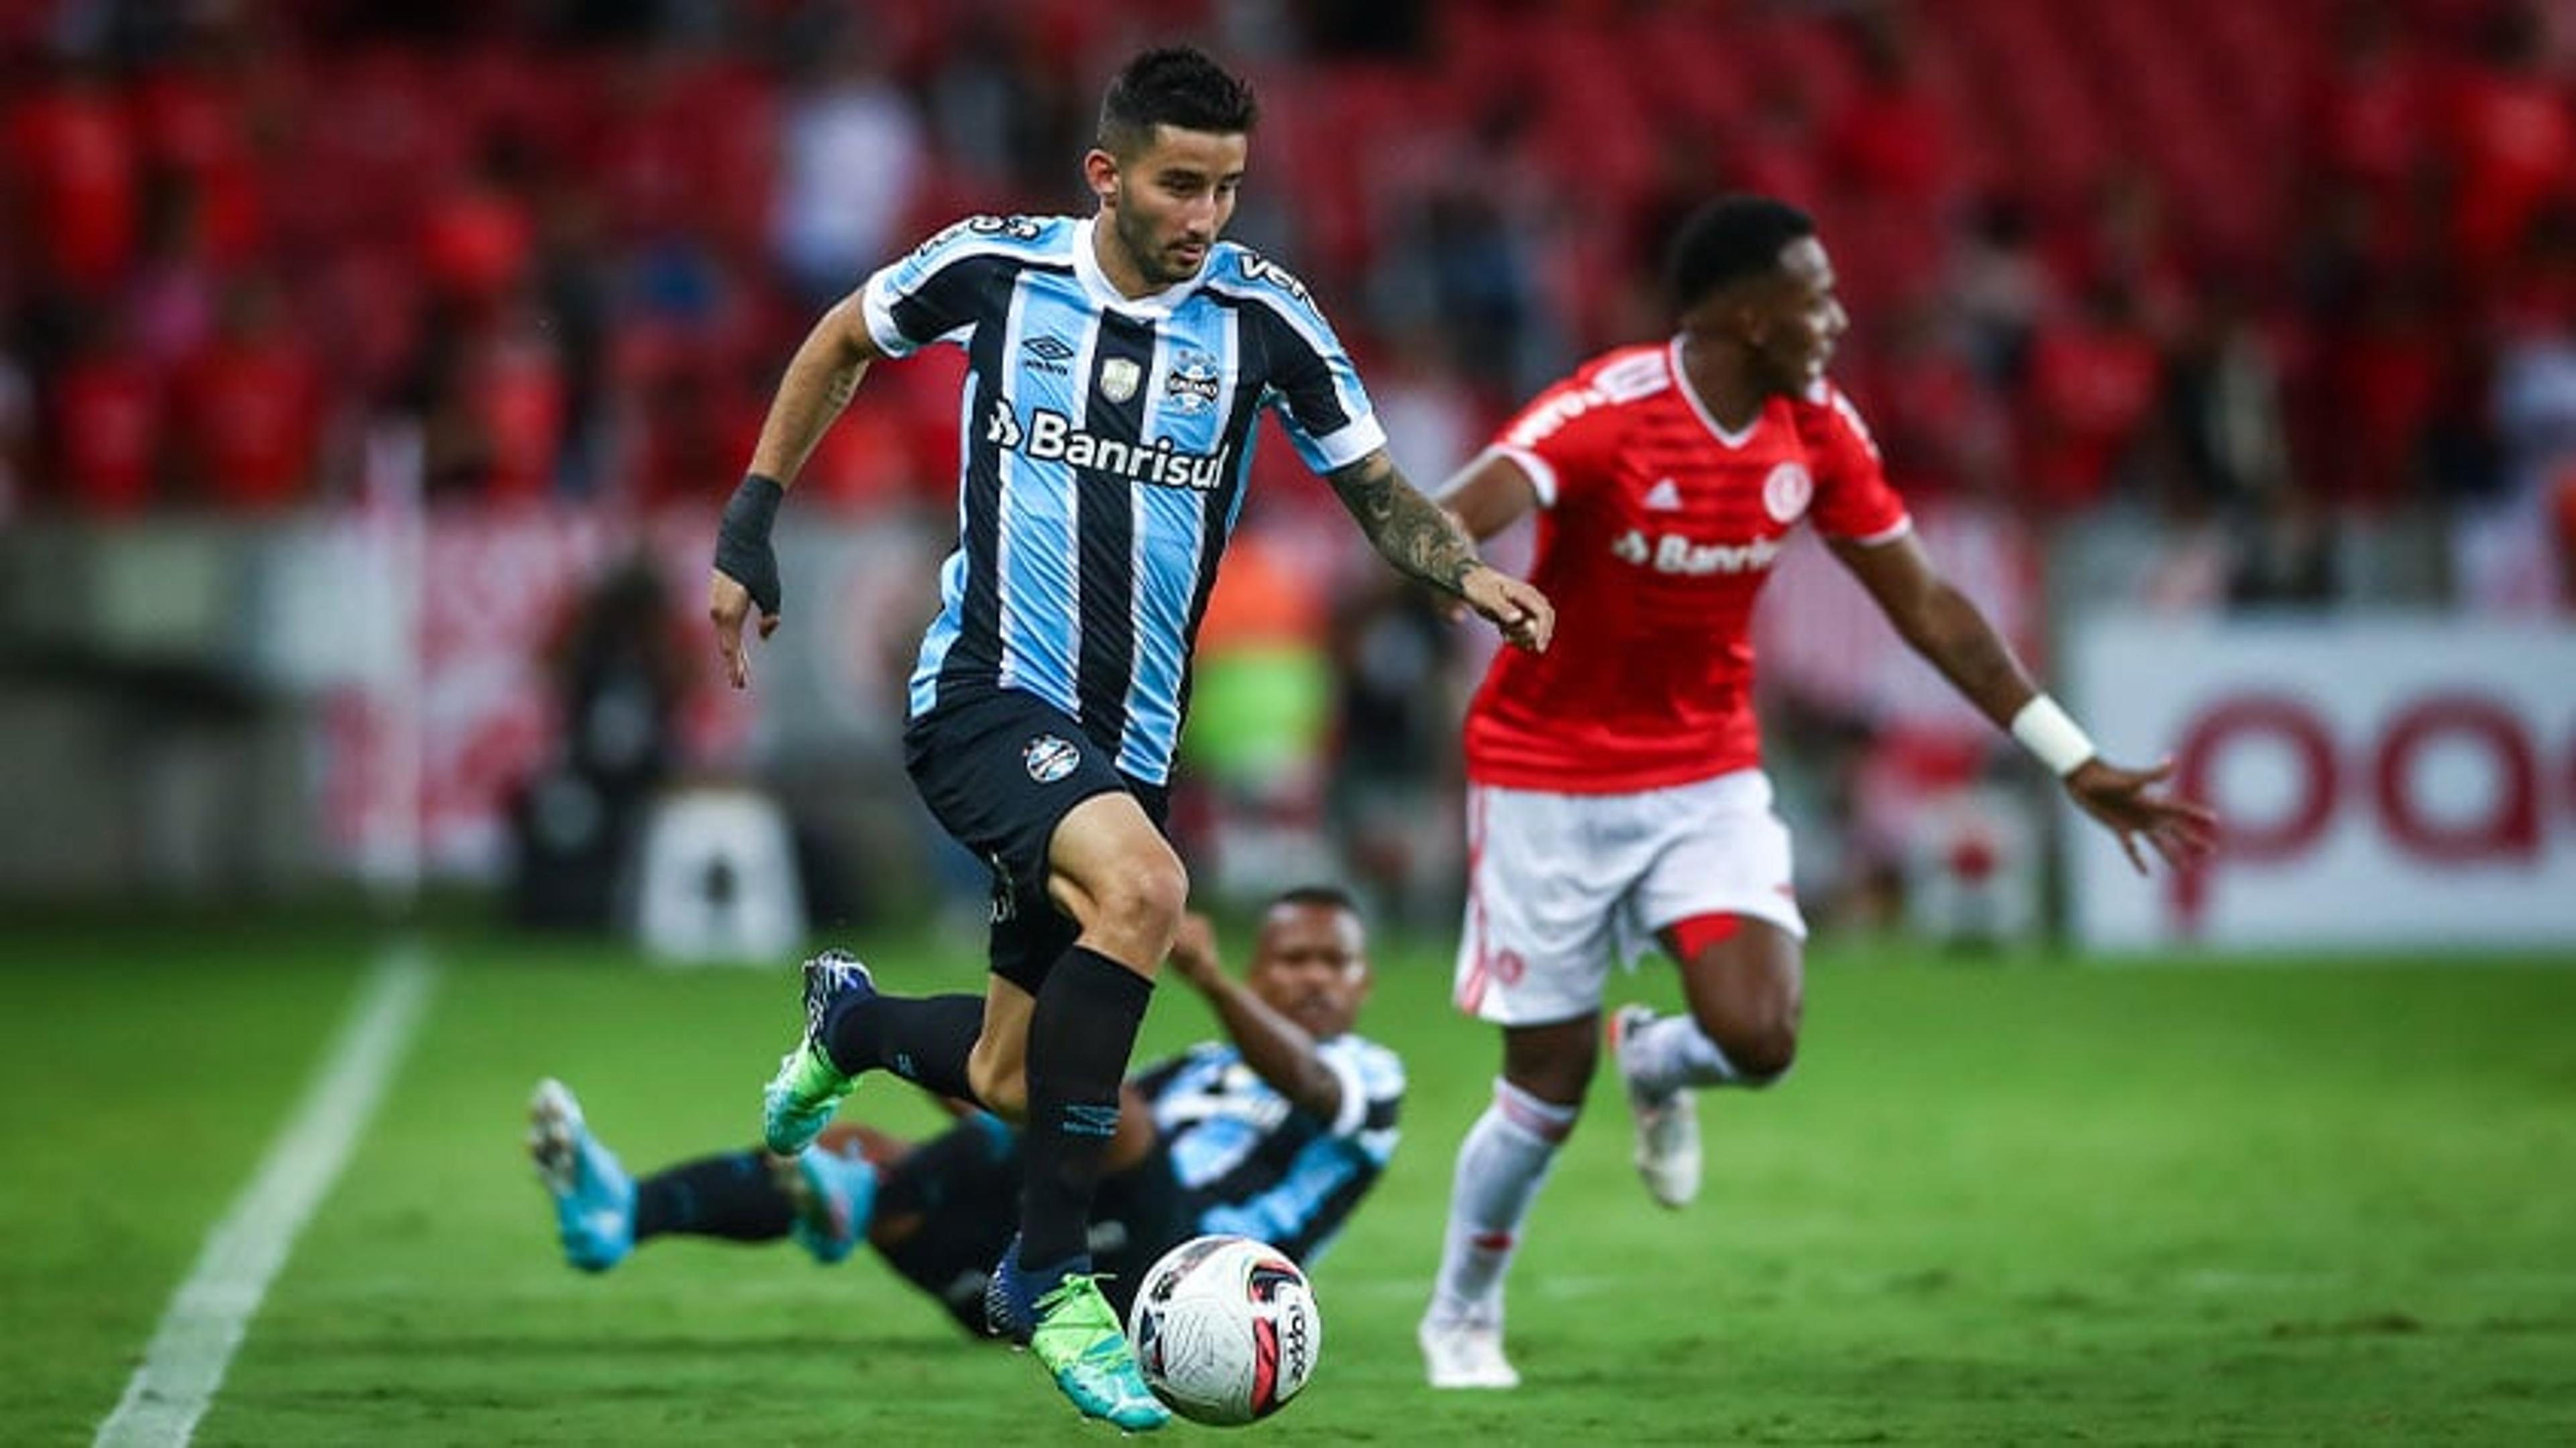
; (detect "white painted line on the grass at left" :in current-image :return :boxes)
[95,943,433,1448]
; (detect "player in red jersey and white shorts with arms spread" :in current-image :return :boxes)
[1419,196,2215,1389]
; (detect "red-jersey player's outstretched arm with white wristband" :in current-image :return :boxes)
[1834,533,2218,874]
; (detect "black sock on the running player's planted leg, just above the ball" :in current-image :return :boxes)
[1020,945,1154,1265]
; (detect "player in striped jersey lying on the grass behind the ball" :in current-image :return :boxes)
[528,886,1404,1335]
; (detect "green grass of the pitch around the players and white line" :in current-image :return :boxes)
[0,923,2576,1445]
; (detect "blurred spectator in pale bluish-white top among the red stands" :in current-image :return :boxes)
[773,42,927,304]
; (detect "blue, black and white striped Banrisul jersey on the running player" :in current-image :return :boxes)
[861,217,1386,783]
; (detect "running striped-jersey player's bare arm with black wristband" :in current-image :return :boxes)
[706,291,883,688]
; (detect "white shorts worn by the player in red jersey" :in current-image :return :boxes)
[1456,770,1806,1025]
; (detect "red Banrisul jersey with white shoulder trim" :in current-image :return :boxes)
[1466,340,1909,794]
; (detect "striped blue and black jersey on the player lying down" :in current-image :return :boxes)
[1136,1036,1404,1265]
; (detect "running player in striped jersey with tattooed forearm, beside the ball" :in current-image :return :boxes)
[708,49,1554,1427]
